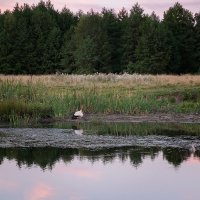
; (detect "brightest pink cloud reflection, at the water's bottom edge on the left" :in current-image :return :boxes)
[26,183,54,200]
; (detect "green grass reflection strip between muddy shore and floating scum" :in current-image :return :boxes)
[55,122,200,136]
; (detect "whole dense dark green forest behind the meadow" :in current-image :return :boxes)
[0,1,200,74]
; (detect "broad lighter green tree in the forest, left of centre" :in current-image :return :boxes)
[63,11,102,74]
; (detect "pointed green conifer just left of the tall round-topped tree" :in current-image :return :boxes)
[127,13,171,74]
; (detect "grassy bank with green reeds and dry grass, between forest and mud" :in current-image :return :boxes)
[0,74,200,121]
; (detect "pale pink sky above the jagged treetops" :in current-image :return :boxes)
[0,0,200,18]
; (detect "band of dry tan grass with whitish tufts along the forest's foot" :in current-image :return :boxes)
[0,74,200,88]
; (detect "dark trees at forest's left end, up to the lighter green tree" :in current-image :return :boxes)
[0,1,75,74]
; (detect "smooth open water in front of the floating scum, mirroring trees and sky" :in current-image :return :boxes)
[0,147,200,200]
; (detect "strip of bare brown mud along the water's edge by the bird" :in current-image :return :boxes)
[39,113,200,123]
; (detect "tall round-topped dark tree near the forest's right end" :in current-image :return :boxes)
[163,3,196,74]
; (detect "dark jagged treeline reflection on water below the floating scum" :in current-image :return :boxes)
[0,147,200,169]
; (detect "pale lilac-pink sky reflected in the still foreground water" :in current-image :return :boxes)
[0,154,200,200]
